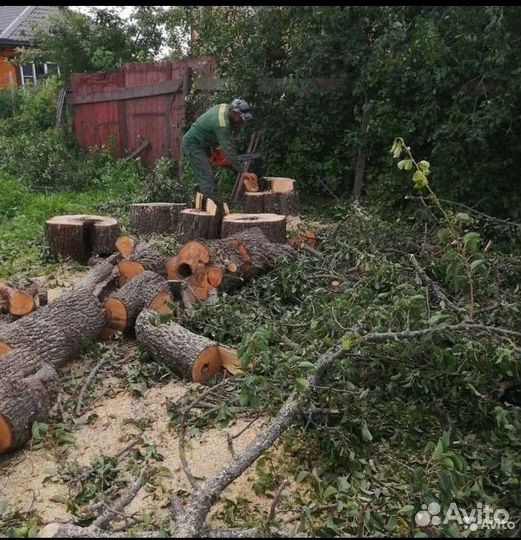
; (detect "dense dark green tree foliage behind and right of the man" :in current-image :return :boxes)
[166,6,521,219]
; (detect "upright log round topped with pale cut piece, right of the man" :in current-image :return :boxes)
[244,177,299,216]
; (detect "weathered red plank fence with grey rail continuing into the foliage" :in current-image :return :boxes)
[66,56,349,167]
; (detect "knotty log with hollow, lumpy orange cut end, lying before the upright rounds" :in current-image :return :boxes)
[167,226,295,303]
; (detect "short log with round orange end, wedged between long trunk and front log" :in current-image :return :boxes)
[103,270,168,332]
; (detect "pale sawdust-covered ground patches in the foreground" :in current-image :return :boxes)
[0,372,288,523]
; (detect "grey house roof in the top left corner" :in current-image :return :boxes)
[0,6,61,42]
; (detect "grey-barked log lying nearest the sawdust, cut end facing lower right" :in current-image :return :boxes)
[136,309,238,383]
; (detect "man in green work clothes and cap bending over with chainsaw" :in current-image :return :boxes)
[183,99,252,202]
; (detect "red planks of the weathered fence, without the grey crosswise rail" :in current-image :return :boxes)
[71,57,216,167]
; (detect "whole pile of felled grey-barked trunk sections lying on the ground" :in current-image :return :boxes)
[0,216,295,453]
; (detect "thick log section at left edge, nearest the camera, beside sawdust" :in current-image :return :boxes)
[0,349,58,454]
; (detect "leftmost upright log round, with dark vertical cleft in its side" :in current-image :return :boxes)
[45,215,120,264]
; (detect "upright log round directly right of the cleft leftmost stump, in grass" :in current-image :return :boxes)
[130,203,186,234]
